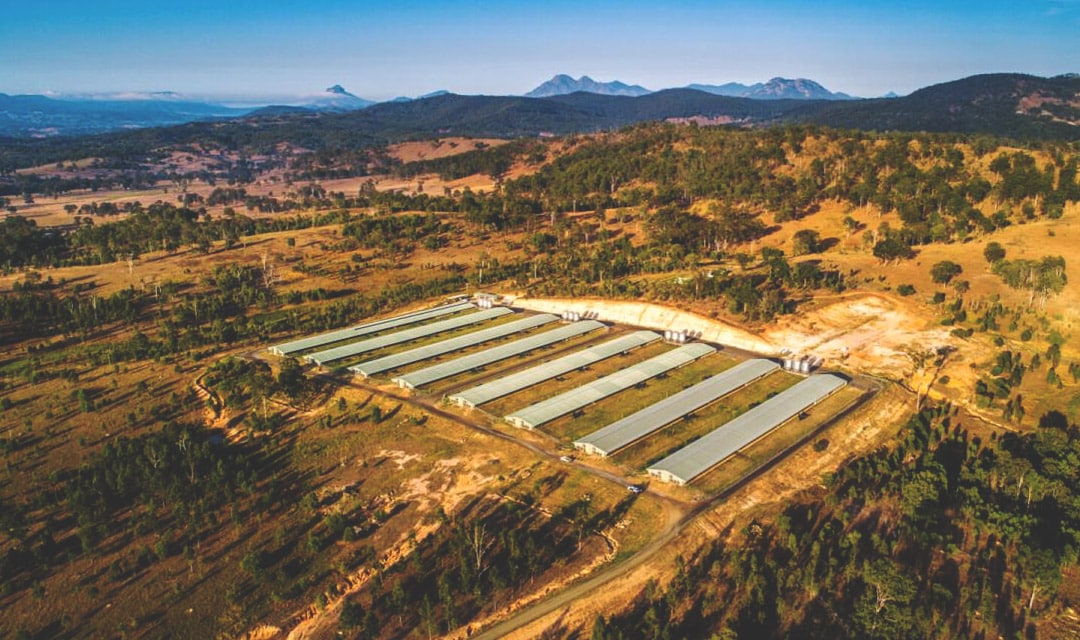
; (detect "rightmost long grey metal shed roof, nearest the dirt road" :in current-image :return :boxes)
[648,373,847,485]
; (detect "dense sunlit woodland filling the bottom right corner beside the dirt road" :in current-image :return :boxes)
[593,408,1080,640]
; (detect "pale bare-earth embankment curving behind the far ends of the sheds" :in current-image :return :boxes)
[512,298,778,354]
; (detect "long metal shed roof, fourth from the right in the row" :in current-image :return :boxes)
[449,331,660,407]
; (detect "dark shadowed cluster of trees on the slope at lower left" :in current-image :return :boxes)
[0,422,267,595]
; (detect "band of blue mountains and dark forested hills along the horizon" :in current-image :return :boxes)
[0,73,1080,149]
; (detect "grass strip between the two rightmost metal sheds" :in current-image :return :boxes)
[613,371,801,472]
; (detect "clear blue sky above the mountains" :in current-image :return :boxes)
[0,0,1080,99]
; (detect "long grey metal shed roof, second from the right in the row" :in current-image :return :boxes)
[573,359,780,455]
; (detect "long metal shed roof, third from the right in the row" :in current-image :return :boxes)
[507,342,716,428]
